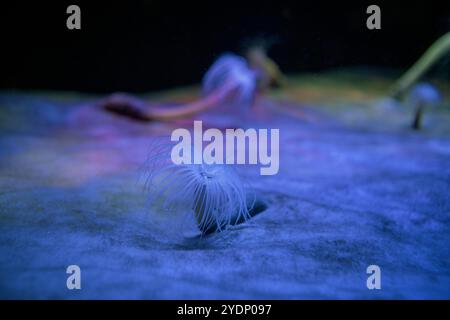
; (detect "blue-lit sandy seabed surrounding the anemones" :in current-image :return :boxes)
[0,71,450,299]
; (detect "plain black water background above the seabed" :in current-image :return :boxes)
[0,0,450,92]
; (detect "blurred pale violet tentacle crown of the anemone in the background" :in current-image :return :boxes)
[202,53,256,105]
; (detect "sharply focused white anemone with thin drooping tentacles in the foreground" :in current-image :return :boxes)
[142,141,255,234]
